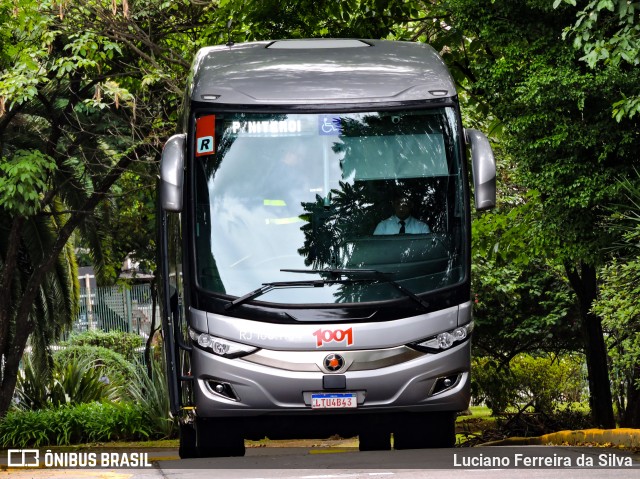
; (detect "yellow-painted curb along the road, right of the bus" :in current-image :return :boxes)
[481,428,640,448]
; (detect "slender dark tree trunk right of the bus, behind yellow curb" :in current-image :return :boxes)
[565,262,616,429]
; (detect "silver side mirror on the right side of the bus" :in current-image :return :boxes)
[464,129,496,210]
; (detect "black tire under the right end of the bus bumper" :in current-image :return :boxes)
[393,412,456,449]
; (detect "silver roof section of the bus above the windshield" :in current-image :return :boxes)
[187,39,456,105]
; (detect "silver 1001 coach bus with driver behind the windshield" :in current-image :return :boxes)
[158,39,496,457]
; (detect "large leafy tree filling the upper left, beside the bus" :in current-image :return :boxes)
[0,0,222,417]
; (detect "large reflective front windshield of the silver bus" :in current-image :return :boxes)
[192,107,468,306]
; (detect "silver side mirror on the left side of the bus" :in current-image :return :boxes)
[160,134,187,212]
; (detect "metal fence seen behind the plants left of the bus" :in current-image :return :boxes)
[73,284,160,338]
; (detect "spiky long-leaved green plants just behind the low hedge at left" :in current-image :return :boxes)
[16,356,117,410]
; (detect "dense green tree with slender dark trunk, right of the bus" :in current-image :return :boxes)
[432,0,640,427]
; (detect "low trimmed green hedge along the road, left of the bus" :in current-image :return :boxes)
[0,402,151,448]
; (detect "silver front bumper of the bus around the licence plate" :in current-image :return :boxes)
[191,341,470,417]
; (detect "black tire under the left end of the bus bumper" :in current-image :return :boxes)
[196,418,245,457]
